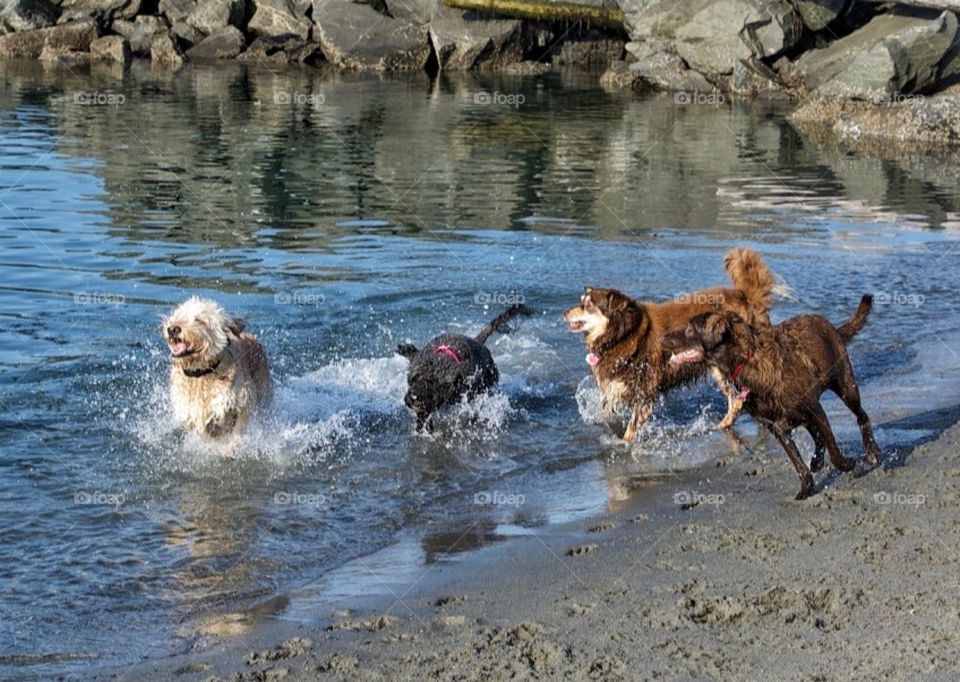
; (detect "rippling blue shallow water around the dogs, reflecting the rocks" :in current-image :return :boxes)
[0,65,960,677]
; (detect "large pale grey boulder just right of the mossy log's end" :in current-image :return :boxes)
[622,0,803,75]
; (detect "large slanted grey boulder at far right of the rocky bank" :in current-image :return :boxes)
[790,12,957,100]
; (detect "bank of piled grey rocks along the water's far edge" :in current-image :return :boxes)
[0,0,960,144]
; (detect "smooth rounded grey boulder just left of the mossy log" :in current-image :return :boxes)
[313,0,430,71]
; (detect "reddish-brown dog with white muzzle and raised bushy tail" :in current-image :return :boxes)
[563,248,775,443]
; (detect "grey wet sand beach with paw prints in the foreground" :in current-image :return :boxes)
[109,415,960,680]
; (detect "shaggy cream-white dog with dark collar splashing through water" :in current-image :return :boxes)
[162,296,273,446]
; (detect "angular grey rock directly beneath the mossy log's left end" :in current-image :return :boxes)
[429,8,523,71]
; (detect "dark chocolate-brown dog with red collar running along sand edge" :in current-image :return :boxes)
[663,295,880,500]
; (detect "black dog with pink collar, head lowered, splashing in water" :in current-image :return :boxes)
[397,305,533,431]
